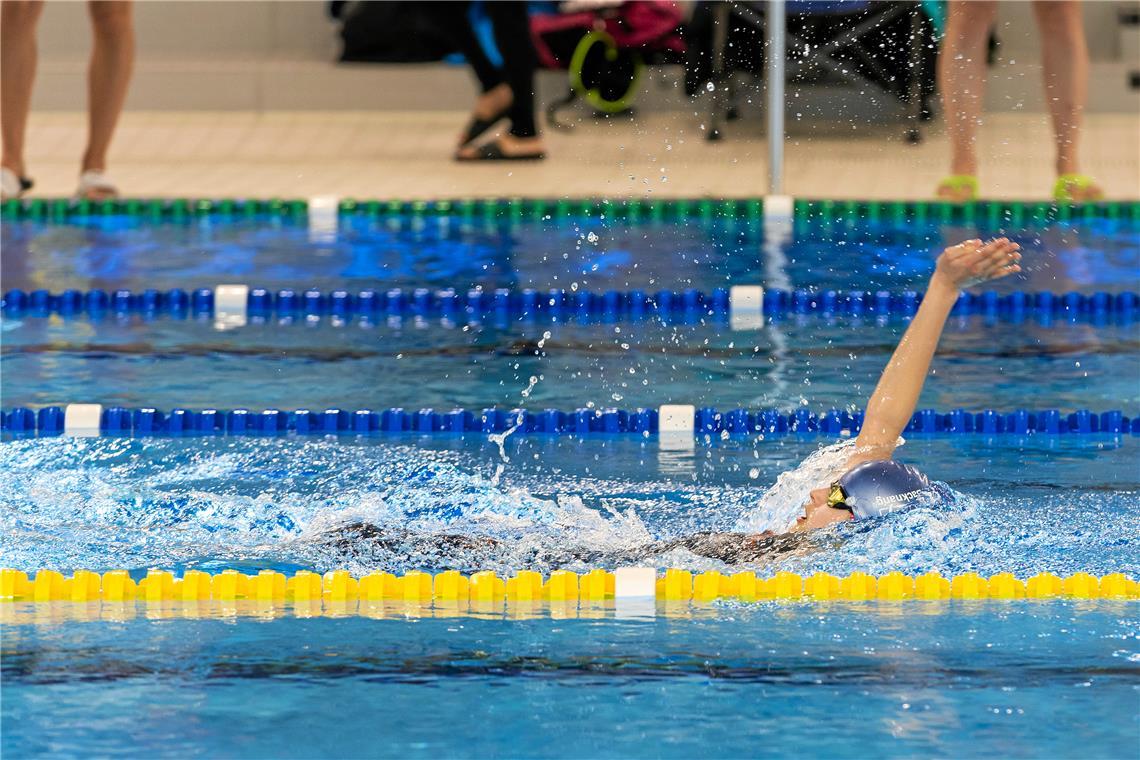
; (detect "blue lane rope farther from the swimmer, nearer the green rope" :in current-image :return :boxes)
[0,287,1140,322]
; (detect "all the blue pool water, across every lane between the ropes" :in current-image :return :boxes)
[0,209,1140,758]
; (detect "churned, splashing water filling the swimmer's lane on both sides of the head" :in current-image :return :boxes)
[0,438,1140,575]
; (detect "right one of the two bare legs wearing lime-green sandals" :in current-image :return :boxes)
[1033,0,1104,199]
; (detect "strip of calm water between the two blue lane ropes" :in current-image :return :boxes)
[0,317,1140,411]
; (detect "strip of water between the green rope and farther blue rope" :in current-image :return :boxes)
[0,214,1140,293]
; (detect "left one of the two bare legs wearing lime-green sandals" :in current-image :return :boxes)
[938,0,998,201]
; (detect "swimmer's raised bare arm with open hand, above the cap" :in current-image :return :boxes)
[847,237,1021,469]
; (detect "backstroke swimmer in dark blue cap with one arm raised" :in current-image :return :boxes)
[329,238,1021,569]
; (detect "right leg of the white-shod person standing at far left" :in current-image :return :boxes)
[82,0,135,198]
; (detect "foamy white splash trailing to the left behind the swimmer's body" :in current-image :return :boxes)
[0,438,651,571]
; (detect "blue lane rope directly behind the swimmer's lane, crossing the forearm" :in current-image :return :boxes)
[0,407,1140,436]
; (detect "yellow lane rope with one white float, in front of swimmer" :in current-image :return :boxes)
[0,567,1140,605]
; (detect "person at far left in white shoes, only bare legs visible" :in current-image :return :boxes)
[0,0,135,201]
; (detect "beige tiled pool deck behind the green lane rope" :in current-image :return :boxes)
[17,112,1140,199]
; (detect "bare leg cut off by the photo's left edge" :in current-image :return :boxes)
[0,0,43,188]
